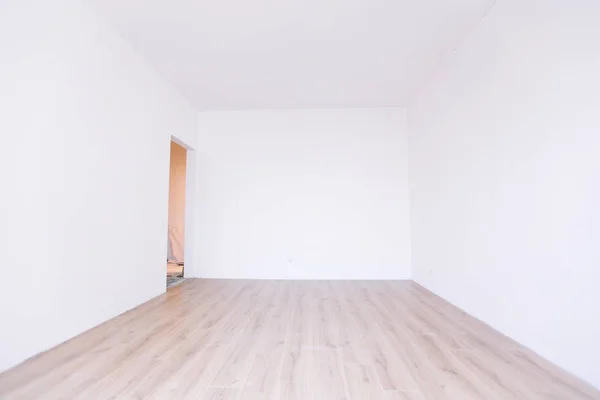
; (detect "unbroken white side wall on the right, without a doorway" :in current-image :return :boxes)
[409,0,600,387]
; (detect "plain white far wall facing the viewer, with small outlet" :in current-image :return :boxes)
[195,108,410,279]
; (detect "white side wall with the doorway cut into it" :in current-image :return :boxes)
[0,0,197,369]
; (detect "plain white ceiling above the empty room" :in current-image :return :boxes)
[90,0,494,110]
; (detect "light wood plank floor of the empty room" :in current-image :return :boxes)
[0,279,600,400]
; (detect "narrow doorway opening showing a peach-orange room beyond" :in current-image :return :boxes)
[167,140,187,287]
